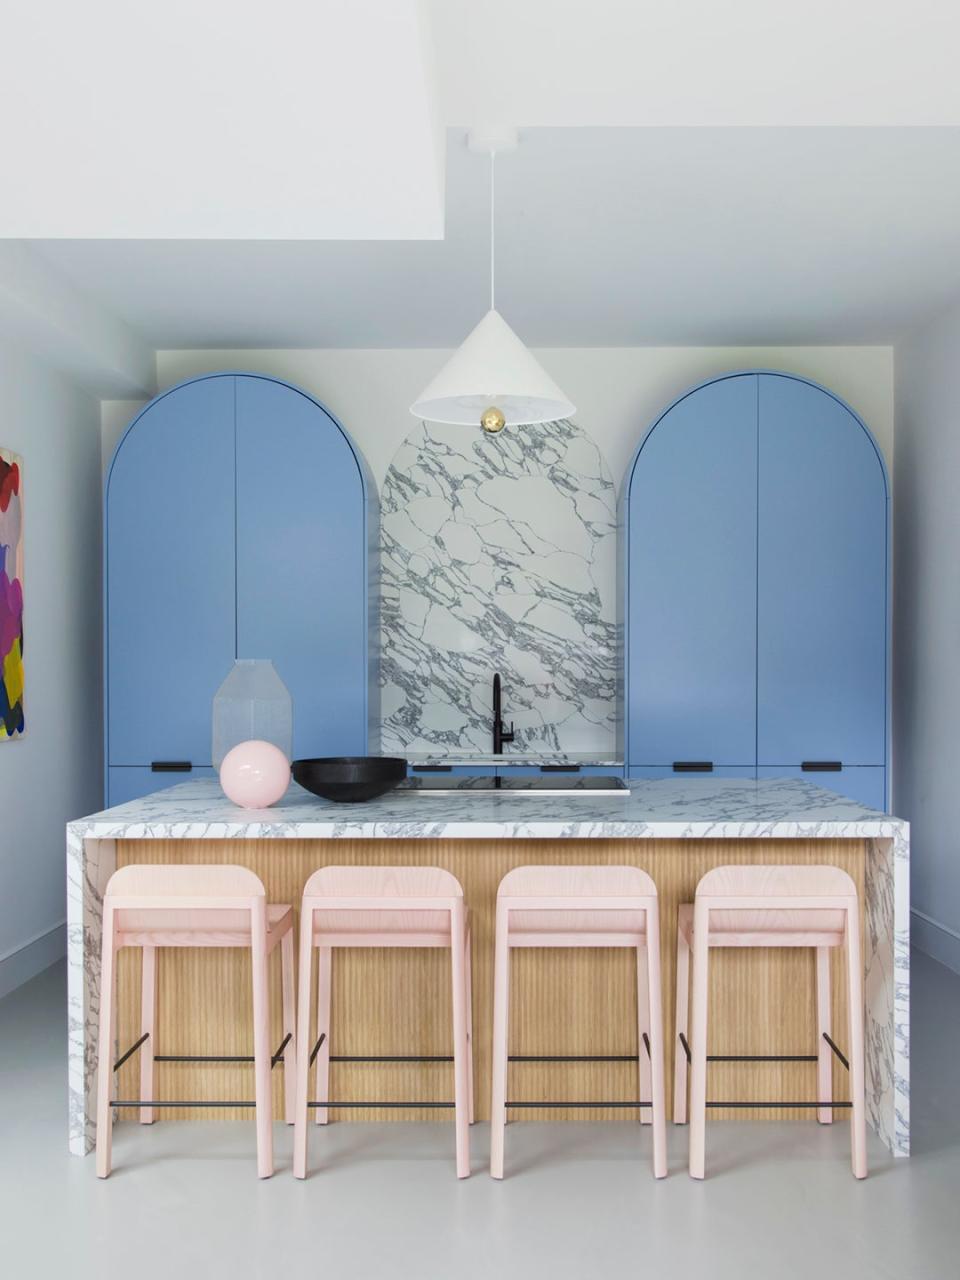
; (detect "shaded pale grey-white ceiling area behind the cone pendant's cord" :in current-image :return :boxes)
[33,128,960,348]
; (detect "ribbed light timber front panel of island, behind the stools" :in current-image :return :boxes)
[118,838,865,1121]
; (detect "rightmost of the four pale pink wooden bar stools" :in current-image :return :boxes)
[673,867,867,1178]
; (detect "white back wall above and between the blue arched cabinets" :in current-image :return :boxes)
[133,347,893,484]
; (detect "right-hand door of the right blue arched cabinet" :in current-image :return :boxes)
[756,374,887,762]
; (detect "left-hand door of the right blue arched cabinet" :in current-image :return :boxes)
[623,374,756,772]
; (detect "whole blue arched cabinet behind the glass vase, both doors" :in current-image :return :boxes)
[105,374,379,804]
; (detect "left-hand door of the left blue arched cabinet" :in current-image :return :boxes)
[105,376,236,765]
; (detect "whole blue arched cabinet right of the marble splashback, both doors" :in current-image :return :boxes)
[621,372,890,809]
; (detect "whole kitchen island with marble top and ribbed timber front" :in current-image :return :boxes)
[67,778,910,1156]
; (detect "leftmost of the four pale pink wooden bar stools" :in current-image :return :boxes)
[96,865,296,1178]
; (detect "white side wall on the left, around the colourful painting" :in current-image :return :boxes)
[0,342,102,996]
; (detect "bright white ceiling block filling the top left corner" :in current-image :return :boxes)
[0,0,443,239]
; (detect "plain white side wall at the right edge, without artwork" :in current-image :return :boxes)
[893,306,960,973]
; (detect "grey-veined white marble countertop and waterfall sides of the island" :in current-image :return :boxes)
[67,778,910,1155]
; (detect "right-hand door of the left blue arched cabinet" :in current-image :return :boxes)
[237,376,369,758]
